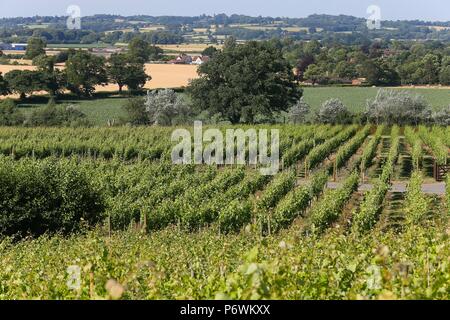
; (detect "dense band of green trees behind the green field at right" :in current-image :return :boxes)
[283,41,450,86]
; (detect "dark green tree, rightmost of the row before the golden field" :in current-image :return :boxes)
[107,54,151,92]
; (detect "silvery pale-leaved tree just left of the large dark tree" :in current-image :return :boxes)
[145,89,191,126]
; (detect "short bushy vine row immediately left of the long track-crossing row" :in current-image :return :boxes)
[310,172,359,234]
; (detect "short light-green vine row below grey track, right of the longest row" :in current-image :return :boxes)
[404,171,431,224]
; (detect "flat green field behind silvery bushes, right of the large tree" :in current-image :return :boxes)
[304,87,450,112]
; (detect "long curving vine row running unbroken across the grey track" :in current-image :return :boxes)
[353,126,400,233]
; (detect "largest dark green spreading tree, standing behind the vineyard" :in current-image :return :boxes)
[188,38,302,123]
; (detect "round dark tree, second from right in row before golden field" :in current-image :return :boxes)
[65,51,108,96]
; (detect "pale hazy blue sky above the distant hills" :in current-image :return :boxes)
[0,0,450,21]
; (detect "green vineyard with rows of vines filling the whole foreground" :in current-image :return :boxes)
[0,125,450,299]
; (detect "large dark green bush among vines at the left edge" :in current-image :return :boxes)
[0,158,104,237]
